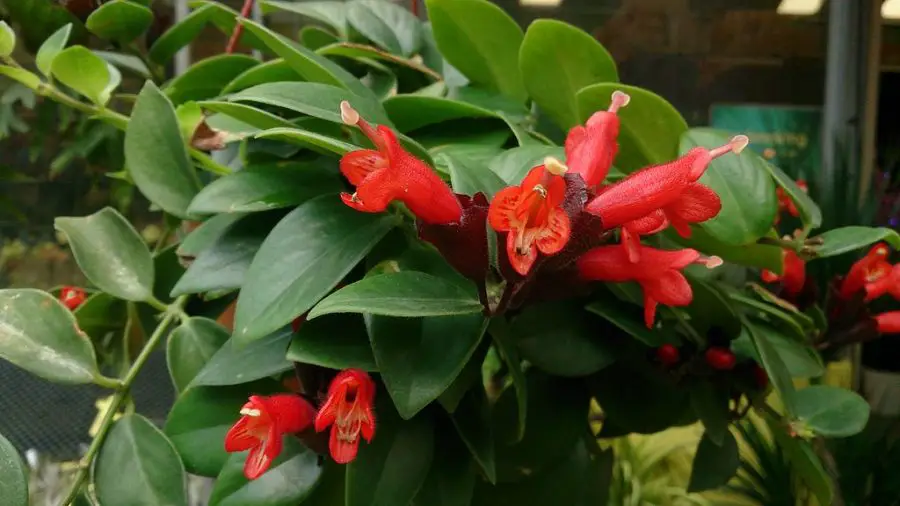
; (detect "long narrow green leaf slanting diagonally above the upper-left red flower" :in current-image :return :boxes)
[241,19,373,97]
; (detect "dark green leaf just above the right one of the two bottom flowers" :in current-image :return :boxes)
[286,315,378,371]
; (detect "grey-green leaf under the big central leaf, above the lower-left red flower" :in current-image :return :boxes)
[190,327,292,387]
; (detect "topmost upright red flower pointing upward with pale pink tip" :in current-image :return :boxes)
[566,91,631,188]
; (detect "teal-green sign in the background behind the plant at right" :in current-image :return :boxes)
[710,104,822,179]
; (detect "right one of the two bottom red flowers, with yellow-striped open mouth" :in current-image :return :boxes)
[316,369,375,464]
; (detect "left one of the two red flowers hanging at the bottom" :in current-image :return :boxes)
[225,394,316,480]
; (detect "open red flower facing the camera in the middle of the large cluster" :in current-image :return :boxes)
[488,158,570,276]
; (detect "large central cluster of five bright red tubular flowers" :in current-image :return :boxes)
[341,98,749,327]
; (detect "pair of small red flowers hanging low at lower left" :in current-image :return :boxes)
[225,369,375,480]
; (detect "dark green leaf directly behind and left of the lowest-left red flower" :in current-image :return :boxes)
[164,382,279,476]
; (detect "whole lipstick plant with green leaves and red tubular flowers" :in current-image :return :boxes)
[0,0,884,506]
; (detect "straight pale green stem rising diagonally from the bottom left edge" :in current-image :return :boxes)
[60,295,187,506]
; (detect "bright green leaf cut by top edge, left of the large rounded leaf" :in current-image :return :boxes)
[425,0,528,102]
